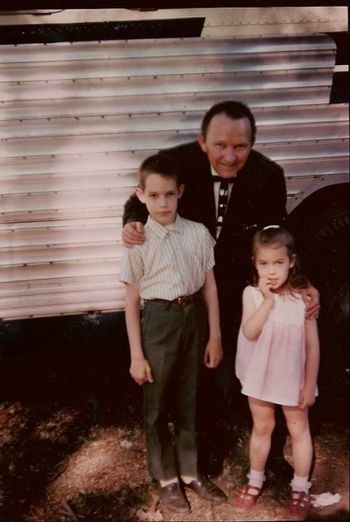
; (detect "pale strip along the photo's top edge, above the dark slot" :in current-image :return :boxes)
[0,7,348,37]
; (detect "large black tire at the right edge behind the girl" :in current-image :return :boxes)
[303,209,349,419]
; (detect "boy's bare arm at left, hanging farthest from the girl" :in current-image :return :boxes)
[125,283,153,384]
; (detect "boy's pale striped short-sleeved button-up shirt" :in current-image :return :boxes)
[120,215,215,301]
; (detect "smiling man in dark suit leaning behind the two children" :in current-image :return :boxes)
[122,101,319,476]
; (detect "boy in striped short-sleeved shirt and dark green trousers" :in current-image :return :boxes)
[120,154,227,514]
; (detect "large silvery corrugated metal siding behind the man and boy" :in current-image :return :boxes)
[0,35,348,319]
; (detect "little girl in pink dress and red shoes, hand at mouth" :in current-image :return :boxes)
[234,225,319,520]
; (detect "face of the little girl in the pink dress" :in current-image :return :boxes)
[254,243,295,292]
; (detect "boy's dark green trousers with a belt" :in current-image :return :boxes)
[142,301,207,480]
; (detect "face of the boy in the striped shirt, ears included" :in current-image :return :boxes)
[136,174,184,225]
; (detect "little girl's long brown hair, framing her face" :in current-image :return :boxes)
[252,225,309,290]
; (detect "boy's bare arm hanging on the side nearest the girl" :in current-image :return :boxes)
[203,269,223,368]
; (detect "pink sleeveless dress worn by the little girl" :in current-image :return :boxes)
[236,286,314,406]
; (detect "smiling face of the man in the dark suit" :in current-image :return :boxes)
[198,114,252,178]
